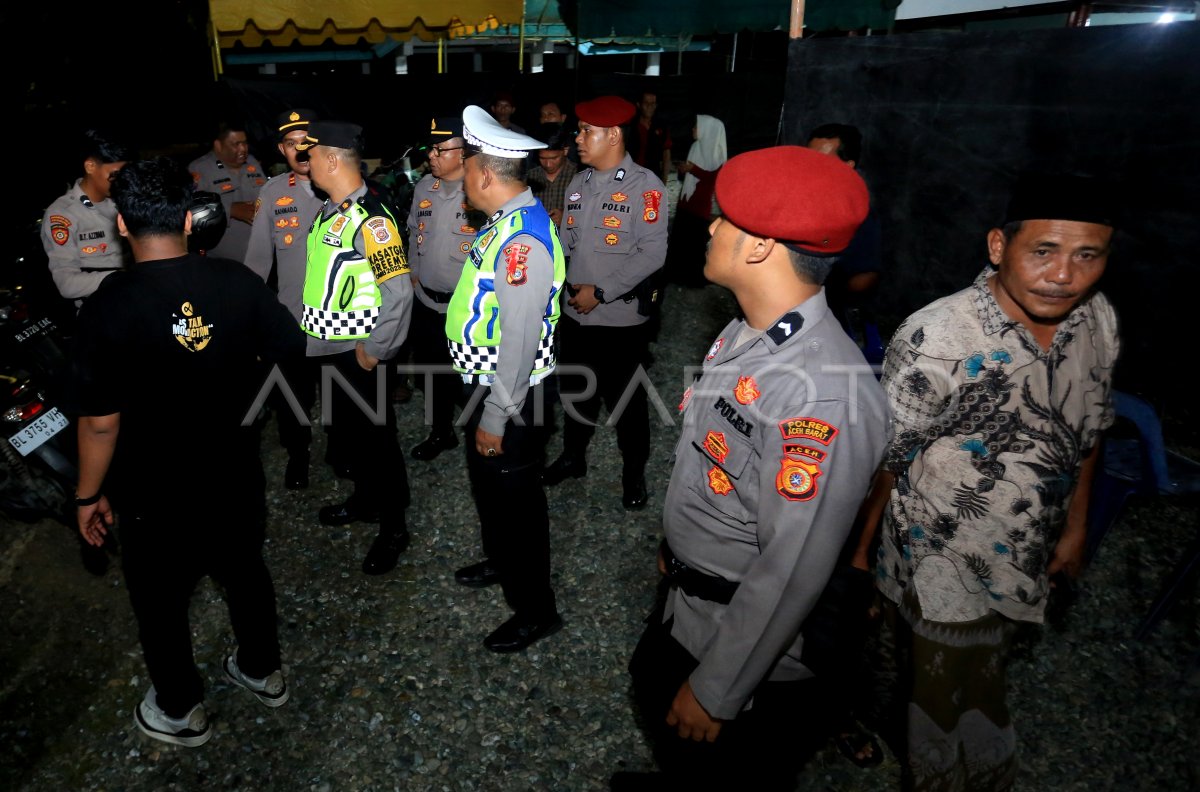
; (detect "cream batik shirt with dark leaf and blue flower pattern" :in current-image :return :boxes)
[877,266,1120,622]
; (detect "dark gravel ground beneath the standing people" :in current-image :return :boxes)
[0,286,1200,792]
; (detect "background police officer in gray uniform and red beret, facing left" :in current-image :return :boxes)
[542,96,667,509]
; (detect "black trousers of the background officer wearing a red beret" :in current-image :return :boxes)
[558,314,650,473]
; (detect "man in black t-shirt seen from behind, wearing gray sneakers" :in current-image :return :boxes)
[74,158,304,748]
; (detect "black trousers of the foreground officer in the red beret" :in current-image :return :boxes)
[629,605,830,792]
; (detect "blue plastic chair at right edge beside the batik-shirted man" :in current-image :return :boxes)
[1086,391,1200,640]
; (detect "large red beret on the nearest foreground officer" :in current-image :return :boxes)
[716,145,870,256]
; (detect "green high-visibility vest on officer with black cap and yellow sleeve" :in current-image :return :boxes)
[300,196,407,340]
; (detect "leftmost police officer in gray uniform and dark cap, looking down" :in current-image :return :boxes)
[42,130,132,308]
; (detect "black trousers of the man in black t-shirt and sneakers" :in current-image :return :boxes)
[118,468,280,718]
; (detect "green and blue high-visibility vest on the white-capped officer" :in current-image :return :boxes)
[446,204,566,384]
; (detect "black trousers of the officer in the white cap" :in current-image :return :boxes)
[464,385,558,620]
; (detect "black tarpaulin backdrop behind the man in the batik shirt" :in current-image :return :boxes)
[784,23,1200,404]
